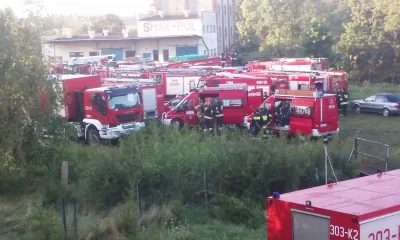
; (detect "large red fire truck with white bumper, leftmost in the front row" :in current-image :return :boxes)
[56,75,144,142]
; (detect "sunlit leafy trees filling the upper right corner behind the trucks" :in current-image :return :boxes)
[237,0,400,83]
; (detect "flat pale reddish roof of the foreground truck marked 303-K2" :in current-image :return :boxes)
[279,170,400,221]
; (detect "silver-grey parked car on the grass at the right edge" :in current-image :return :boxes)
[350,93,400,117]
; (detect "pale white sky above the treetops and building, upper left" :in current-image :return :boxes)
[0,0,151,16]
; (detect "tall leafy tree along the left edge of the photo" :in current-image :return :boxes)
[0,9,58,170]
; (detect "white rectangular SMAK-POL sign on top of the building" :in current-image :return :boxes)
[138,19,202,37]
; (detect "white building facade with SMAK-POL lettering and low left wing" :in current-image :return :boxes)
[43,12,219,63]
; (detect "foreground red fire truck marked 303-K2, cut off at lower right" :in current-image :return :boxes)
[266,170,400,240]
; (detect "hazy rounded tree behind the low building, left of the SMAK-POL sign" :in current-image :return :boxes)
[75,14,125,35]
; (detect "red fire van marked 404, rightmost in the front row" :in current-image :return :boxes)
[244,90,339,137]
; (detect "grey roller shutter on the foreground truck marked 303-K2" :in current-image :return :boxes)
[292,211,330,240]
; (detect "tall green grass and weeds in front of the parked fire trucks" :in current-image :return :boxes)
[0,113,360,239]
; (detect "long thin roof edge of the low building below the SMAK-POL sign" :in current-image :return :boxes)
[46,35,201,43]
